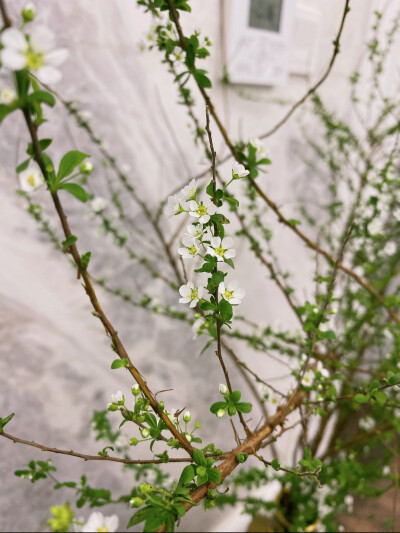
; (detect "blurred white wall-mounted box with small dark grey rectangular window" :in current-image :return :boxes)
[226,0,321,85]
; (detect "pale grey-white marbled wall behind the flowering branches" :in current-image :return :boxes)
[0,0,390,531]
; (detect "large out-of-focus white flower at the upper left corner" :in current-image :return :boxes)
[1,26,68,83]
